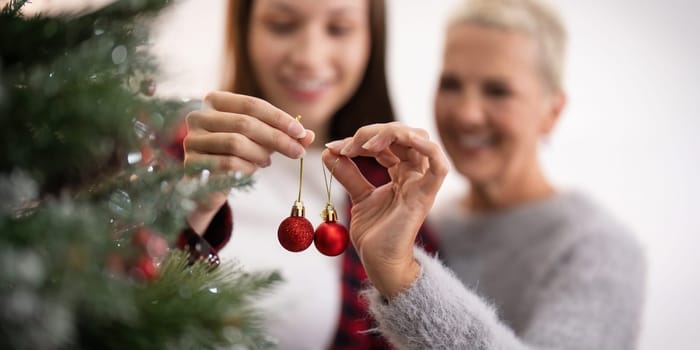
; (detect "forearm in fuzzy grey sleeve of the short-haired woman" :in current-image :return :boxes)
[367,249,527,349]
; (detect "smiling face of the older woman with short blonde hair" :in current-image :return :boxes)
[435,24,564,186]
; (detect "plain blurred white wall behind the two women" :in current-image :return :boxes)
[13,0,700,349]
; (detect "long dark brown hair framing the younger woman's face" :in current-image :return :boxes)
[221,0,395,140]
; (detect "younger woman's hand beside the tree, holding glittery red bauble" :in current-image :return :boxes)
[184,92,314,234]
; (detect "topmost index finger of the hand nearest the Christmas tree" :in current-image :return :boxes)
[204,91,306,139]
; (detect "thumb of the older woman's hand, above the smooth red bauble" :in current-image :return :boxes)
[321,149,375,203]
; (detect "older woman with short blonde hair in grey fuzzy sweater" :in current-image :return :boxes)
[325,0,645,350]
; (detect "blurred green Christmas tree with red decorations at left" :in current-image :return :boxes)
[0,0,279,349]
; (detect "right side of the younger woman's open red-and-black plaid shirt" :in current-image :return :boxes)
[331,158,437,350]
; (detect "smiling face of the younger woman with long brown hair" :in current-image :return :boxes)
[248,0,370,137]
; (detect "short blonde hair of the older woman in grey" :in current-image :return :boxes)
[449,0,566,92]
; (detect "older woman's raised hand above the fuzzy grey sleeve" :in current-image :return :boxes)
[323,123,448,296]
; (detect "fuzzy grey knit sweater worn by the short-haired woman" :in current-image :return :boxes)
[366,193,646,350]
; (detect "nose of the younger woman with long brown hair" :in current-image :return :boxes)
[290,24,328,70]
